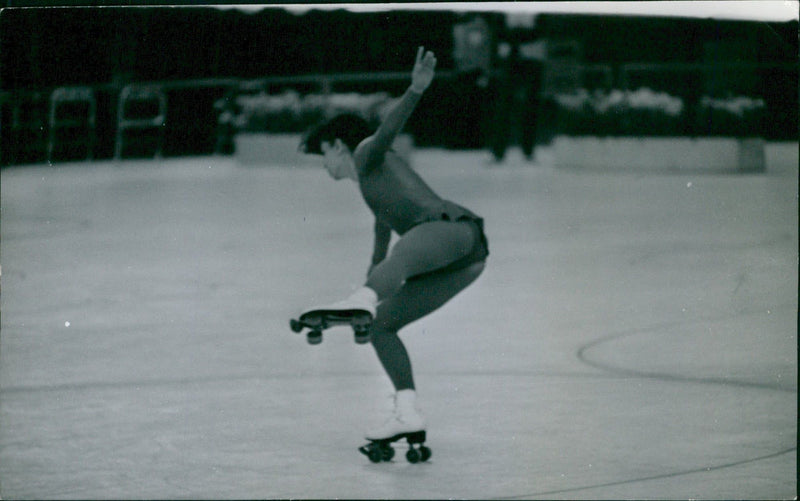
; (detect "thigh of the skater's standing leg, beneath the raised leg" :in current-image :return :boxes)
[373,261,486,332]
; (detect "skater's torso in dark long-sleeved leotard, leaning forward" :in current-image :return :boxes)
[358,150,477,235]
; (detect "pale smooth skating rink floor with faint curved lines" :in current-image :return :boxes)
[0,144,798,499]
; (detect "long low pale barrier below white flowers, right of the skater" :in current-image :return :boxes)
[553,136,766,173]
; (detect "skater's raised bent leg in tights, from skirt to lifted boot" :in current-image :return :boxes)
[365,221,476,300]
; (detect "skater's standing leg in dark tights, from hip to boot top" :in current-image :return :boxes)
[371,262,485,391]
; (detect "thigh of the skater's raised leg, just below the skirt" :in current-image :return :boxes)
[389,221,475,277]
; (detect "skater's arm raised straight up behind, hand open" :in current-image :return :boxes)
[356,47,436,168]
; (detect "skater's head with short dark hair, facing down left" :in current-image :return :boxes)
[300,113,372,180]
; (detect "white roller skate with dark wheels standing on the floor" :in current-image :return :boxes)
[358,390,431,463]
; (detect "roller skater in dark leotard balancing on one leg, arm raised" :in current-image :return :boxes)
[300,47,489,462]
